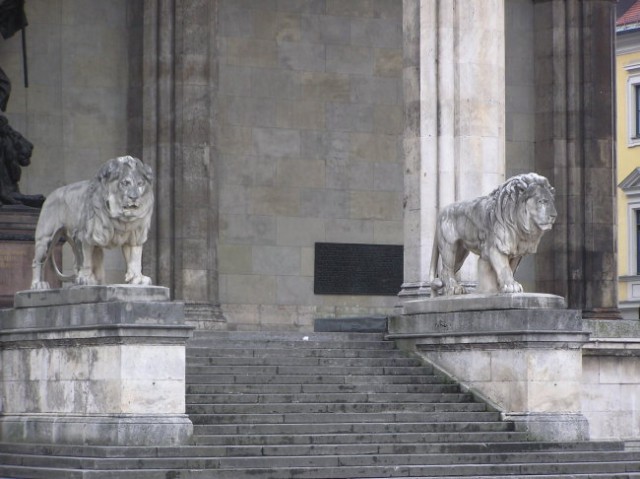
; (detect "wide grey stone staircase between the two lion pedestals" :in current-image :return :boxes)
[0,332,640,479]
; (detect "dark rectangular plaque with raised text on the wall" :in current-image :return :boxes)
[313,243,403,296]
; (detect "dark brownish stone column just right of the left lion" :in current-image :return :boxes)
[130,0,221,328]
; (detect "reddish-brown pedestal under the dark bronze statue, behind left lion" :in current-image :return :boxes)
[0,206,62,308]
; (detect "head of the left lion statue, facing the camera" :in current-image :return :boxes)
[96,156,153,222]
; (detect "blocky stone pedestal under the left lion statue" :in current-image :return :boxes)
[0,285,193,445]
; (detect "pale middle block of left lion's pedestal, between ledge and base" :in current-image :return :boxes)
[1,339,185,415]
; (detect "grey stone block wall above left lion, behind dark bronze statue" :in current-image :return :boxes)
[0,0,128,282]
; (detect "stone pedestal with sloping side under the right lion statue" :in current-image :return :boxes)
[389,293,589,441]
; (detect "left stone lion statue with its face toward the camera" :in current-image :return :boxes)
[31,156,153,289]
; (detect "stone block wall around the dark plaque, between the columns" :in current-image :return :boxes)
[217,0,403,328]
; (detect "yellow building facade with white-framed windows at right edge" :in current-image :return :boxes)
[616,19,640,319]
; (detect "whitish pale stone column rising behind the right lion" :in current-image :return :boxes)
[400,0,505,296]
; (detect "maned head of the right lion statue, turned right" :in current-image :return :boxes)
[489,173,558,253]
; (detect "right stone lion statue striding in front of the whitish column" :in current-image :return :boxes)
[429,173,557,295]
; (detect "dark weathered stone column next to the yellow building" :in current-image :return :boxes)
[534,0,620,319]
